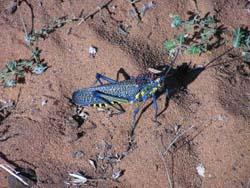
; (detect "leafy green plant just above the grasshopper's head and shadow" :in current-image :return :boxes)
[164,13,222,57]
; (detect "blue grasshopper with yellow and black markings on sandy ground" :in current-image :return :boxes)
[72,67,170,128]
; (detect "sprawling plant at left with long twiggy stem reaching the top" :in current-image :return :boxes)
[0,0,114,87]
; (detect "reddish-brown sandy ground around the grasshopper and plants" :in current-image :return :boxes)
[0,0,250,188]
